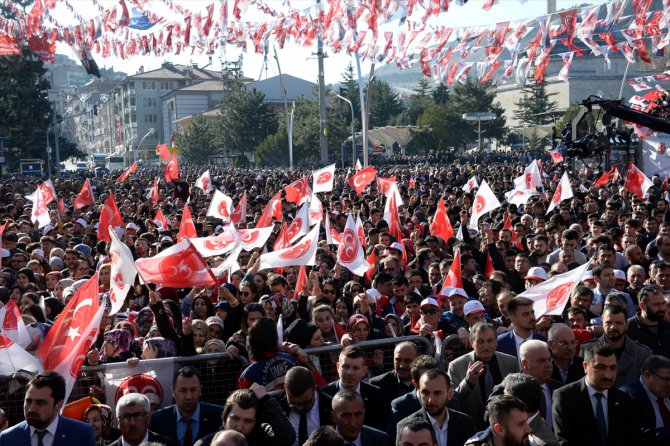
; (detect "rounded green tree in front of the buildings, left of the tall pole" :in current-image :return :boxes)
[217,89,278,158]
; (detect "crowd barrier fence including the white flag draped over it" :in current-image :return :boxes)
[0,336,435,425]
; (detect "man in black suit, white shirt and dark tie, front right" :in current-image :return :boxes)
[552,342,640,446]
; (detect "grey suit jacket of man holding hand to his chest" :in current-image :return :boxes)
[448,352,519,429]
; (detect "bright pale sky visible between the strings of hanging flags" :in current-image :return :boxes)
[54,0,606,84]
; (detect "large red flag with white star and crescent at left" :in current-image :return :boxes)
[36,273,105,401]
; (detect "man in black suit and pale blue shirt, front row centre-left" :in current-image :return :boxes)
[270,366,333,446]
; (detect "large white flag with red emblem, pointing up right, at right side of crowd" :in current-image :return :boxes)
[518,260,592,318]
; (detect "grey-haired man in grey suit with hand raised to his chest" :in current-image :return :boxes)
[449,322,519,429]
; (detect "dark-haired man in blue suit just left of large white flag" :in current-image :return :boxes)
[497,297,547,358]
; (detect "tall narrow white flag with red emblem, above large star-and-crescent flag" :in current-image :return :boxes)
[108,229,137,316]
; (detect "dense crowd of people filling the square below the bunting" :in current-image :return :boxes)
[0,155,670,446]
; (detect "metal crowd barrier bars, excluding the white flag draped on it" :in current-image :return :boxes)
[0,335,434,426]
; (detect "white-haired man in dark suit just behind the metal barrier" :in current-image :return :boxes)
[370,342,418,407]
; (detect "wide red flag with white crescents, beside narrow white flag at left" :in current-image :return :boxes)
[135,238,218,288]
